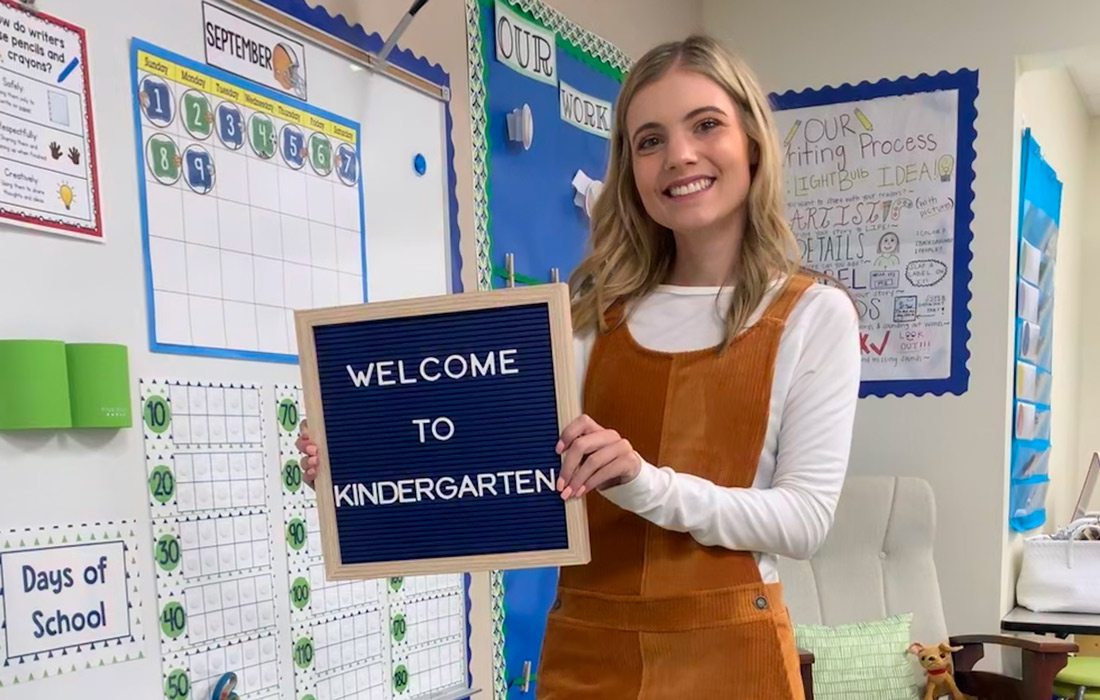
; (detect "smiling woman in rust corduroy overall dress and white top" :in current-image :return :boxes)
[299,36,860,700]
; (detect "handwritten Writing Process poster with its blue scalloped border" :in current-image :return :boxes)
[773,70,978,396]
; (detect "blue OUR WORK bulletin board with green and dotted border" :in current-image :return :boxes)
[466,0,630,699]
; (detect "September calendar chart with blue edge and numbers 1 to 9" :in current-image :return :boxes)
[132,40,366,363]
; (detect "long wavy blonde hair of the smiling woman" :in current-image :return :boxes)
[570,35,801,348]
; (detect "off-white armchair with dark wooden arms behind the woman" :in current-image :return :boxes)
[779,477,1077,700]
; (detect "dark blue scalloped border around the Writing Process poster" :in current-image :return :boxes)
[771,68,978,397]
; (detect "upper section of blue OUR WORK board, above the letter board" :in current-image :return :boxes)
[466,0,629,288]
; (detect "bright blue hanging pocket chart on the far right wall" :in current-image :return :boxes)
[1009,129,1062,532]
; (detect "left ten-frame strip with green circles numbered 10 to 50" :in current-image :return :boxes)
[141,380,279,699]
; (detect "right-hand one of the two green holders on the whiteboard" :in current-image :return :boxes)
[65,342,132,428]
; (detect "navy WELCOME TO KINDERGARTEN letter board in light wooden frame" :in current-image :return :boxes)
[296,284,589,579]
